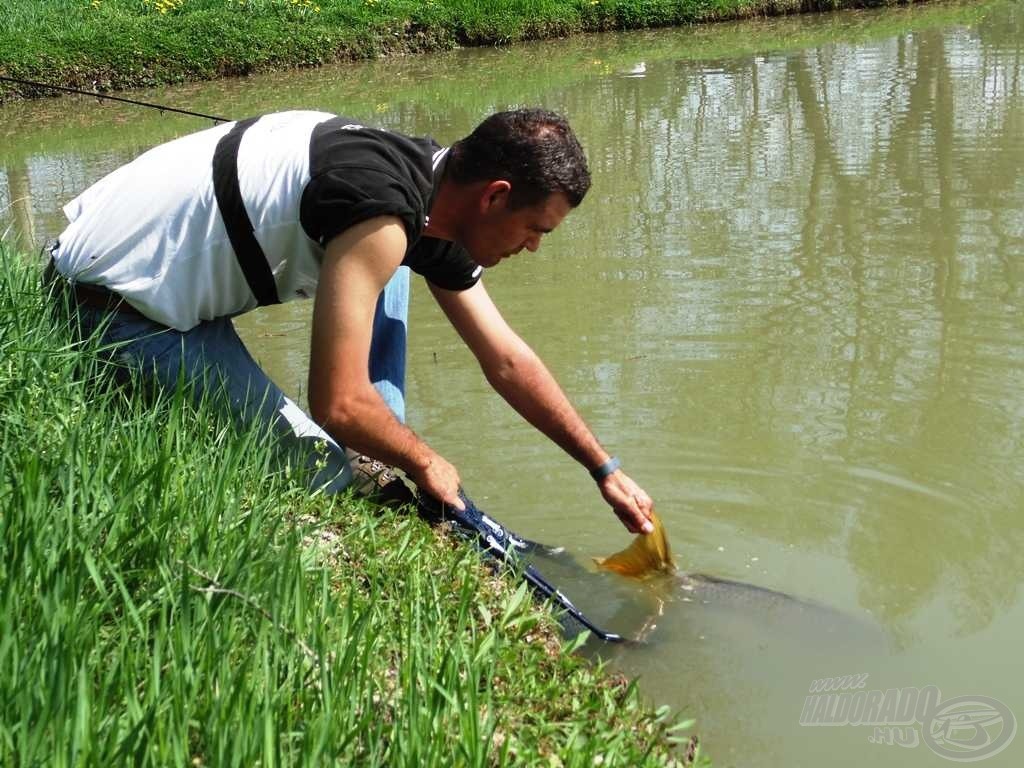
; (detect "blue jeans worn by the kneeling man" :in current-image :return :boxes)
[67,267,409,493]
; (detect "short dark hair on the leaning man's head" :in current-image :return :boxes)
[447,110,590,209]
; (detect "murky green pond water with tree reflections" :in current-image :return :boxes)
[0,2,1024,766]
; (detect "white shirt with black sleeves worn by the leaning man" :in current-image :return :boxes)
[54,112,481,331]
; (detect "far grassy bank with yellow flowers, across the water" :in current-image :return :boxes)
[0,0,929,100]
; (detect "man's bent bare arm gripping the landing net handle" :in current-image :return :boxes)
[309,216,463,509]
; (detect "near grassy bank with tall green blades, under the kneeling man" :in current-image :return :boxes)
[0,245,700,766]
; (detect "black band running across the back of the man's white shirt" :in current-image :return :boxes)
[213,118,281,306]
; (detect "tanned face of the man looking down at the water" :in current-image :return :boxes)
[462,190,572,267]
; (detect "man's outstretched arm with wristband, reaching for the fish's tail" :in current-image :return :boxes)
[431,282,653,534]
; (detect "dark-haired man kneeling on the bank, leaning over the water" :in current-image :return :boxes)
[52,110,651,532]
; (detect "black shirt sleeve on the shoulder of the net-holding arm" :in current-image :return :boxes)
[299,166,423,246]
